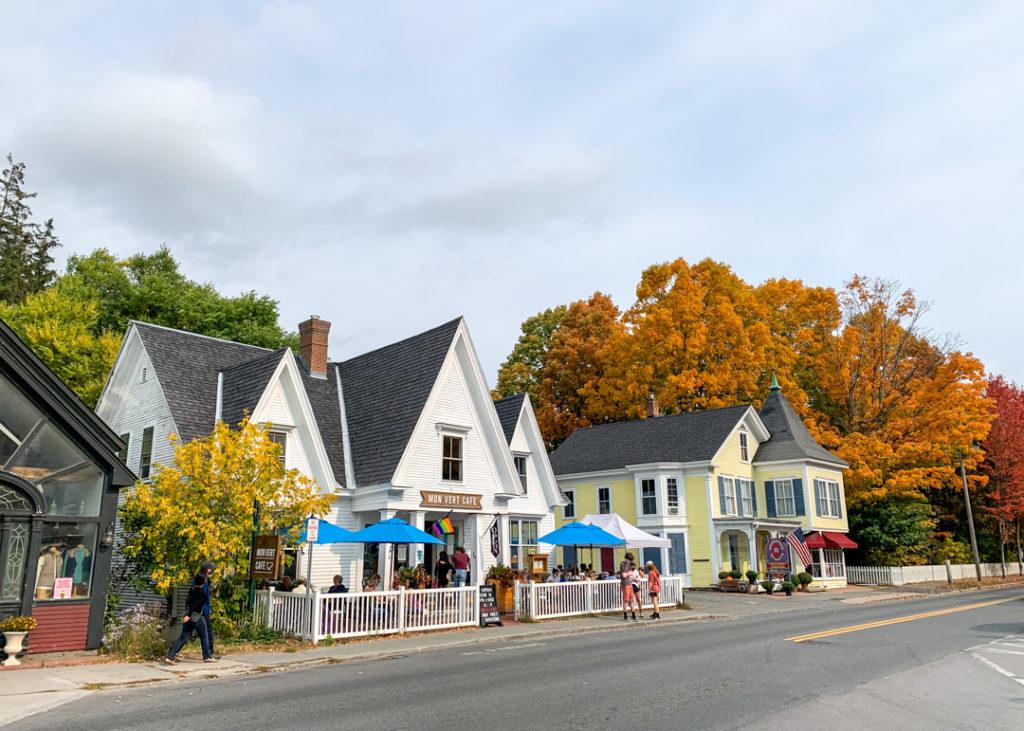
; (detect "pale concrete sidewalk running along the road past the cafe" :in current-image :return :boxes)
[0,587,983,726]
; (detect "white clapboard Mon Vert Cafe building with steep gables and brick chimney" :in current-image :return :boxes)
[96,317,563,590]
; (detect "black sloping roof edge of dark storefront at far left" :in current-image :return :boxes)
[0,320,135,487]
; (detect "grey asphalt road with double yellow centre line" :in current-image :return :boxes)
[10,588,1024,731]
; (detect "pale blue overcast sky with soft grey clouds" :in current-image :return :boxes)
[0,0,1024,384]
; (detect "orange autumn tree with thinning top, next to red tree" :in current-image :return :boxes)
[811,276,991,507]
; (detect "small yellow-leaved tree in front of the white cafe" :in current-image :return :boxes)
[118,419,334,617]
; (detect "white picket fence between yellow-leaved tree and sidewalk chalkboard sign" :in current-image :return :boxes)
[253,587,480,643]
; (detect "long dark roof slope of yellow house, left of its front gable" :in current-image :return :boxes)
[551,405,750,475]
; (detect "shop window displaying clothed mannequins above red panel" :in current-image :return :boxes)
[35,522,97,601]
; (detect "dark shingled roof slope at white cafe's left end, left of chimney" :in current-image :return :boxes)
[132,321,273,443]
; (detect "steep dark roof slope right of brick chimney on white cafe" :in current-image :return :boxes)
[328,317,462,485]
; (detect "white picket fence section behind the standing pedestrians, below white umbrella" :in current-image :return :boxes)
[514,576,683,619]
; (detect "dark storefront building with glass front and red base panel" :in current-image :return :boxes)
[0,321,134,653]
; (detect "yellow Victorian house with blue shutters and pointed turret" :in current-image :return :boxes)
[551,376,856,587]
